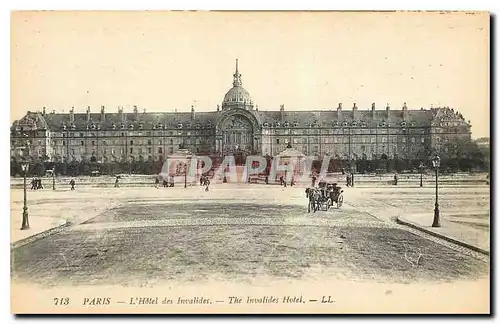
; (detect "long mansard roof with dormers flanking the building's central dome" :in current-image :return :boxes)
[12,107,465,130]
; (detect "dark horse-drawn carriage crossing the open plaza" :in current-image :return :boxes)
[306,181,344,213]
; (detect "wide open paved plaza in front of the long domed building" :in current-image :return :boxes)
[11,184,489,286]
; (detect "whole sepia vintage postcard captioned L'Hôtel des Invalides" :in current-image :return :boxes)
[10,11,491,314]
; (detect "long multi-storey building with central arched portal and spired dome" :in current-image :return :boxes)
[11,61,471,167]
